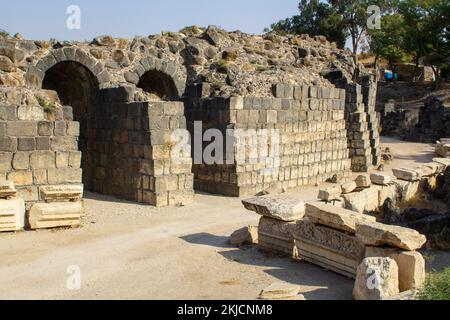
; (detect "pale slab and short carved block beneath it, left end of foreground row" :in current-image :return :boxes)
[242,197,305,257]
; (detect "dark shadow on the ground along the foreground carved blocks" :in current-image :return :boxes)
[181,233,354,300]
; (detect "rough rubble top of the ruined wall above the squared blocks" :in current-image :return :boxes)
[0,26,355,97]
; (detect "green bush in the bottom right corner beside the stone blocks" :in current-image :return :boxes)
[416,267,450,300]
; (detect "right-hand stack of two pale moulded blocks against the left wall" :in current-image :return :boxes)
[28,185,83,230]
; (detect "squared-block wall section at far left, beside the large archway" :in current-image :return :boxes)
[0,105,81,204]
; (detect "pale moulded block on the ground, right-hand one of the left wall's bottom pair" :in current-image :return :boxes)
[28,202,83,229]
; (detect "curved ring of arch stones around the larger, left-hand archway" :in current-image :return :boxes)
[25,47,111,88]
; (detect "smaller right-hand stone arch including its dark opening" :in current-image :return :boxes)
[124,57,186,100]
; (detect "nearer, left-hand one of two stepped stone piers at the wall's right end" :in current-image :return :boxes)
[345,84,376,172]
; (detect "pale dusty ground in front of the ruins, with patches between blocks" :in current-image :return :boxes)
[0,139,450,299]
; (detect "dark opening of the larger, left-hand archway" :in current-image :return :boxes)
[42,61,99,190]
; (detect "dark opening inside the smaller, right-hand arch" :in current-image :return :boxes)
[137,70,179,101]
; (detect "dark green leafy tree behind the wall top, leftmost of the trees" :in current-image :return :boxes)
[271,0,348,48]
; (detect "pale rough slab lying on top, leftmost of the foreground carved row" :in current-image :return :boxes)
[242,197,305,222]
